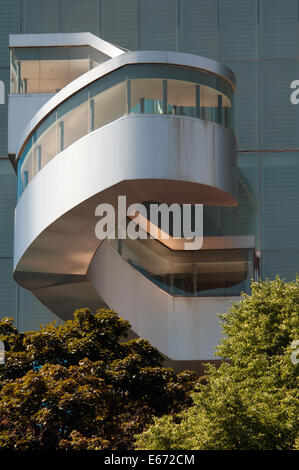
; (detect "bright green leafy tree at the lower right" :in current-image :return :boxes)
[137,278,299,450]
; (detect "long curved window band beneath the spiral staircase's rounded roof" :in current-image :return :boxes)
[18,64,233,196]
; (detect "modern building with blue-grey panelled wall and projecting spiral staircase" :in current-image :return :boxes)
[0,0,299,366]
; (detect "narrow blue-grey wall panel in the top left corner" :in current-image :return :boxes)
[0,0,20,67]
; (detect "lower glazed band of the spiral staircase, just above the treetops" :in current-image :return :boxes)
[109,235,254,297]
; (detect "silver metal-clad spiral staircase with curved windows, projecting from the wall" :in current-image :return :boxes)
[9,35,253,361]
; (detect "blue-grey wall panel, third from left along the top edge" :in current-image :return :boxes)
[61,0,99,34]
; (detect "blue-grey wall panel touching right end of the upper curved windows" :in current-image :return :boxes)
[226,60,259,150]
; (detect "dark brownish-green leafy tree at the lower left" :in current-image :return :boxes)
[0,309,195,449]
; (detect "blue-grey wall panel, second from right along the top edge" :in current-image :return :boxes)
[219,0,257,60]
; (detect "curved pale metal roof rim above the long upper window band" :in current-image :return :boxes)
[16,50,236,161]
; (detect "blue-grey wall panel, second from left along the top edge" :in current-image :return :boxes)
[21,0,60,33]
